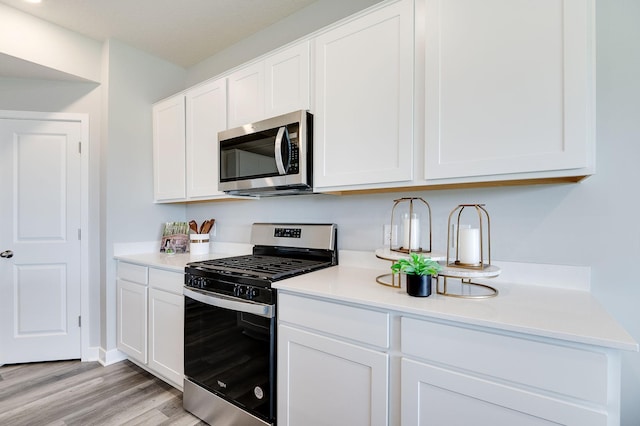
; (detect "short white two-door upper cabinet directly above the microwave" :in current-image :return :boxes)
[228,41,310,128]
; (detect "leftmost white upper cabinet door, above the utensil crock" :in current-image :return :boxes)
[153,94,187,201]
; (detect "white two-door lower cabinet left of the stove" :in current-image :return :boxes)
[116,262,184,389]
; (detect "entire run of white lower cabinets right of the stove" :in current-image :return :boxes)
[278,290,620,426]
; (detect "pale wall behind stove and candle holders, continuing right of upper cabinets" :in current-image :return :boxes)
[187,0,640,426]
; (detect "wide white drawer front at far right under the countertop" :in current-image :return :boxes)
[401,317,612,404]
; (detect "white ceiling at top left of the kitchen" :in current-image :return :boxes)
[0,0,317,68]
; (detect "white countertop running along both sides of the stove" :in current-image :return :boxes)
[115,246,638,351]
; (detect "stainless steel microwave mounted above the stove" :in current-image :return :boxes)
[218,110,313,197]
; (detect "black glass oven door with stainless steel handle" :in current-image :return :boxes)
[184,287,276,423]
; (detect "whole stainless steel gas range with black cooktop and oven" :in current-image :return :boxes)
[183,223,338,426]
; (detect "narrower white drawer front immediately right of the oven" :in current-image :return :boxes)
[278,293,389,348]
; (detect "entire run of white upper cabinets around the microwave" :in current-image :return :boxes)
[154,0,595,197]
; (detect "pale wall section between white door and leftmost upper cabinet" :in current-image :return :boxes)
[101,40,186,352]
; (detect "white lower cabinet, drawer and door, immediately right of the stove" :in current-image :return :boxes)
[278,295,389,426]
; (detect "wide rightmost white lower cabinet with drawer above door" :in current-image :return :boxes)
[400,317,619,426]
